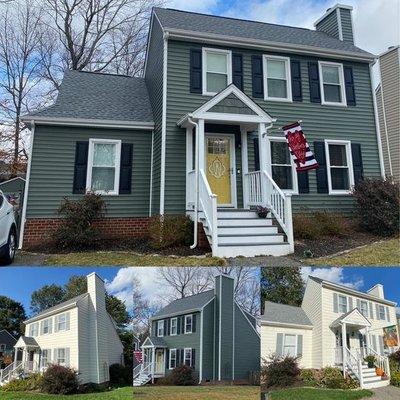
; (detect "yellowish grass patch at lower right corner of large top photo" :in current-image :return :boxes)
[307,238,400,266]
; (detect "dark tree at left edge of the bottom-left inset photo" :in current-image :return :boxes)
[0,296,26,337]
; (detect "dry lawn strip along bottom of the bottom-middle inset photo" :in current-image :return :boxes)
[133,386,260,400]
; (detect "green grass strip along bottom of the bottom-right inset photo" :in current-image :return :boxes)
[269,388,373,400]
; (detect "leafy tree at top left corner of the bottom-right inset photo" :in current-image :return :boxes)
[261,267,304,310]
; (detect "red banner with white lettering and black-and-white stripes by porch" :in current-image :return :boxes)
[282,122,318,172]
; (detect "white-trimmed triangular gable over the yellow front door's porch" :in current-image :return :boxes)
[177,83,276,128]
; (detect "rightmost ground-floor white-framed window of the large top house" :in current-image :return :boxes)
[325,140,354,194]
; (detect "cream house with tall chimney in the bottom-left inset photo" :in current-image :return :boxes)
[0,273,124,384]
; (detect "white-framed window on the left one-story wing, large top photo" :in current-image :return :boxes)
[86,139,121,195]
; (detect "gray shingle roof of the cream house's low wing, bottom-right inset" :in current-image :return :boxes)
[261,301,313,326]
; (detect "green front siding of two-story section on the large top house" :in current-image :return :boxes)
[165,41,380,214]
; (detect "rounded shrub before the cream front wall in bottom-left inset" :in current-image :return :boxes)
[40,365,79,394]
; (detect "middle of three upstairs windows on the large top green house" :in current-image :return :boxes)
[264,55,292,101]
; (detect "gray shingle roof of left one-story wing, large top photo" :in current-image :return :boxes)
[25,71,153,122]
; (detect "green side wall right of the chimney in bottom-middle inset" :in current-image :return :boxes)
[234,304,261,380]
